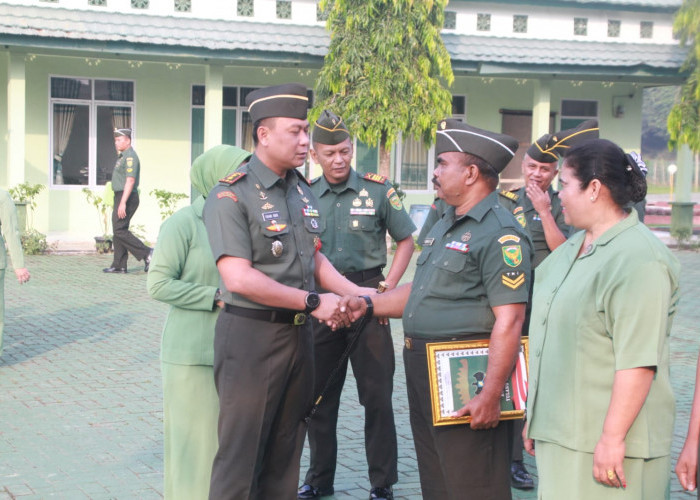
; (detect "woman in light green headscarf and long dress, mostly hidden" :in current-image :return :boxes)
[146,145,250,500]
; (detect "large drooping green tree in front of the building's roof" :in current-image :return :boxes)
[310,0,454,176]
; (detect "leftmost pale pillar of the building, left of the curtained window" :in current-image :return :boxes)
[7,52,26,187]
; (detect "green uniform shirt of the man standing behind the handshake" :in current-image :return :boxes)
[311,169,416,273]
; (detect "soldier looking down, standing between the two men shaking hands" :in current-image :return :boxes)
[298,111,415,499]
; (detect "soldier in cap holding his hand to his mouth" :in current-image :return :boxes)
[499,120,598,490]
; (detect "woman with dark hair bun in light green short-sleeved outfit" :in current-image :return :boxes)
[525,139,680,500]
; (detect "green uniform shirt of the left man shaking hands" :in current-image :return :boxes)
[204,155,321,309]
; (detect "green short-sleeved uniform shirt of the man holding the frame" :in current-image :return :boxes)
[403,192,532,338]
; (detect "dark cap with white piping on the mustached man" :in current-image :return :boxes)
[435,119,518,173]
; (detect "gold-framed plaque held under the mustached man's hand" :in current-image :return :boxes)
[425,337,528,426]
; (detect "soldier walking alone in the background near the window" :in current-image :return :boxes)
[103,128,153,273]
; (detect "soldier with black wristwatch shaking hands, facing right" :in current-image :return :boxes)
[204,84,365,500]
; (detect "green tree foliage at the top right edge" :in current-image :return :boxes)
[668,0,700,152]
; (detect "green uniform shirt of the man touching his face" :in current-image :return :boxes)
[499,186,571,269]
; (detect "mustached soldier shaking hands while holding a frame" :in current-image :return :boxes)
[334,120,531,500]
